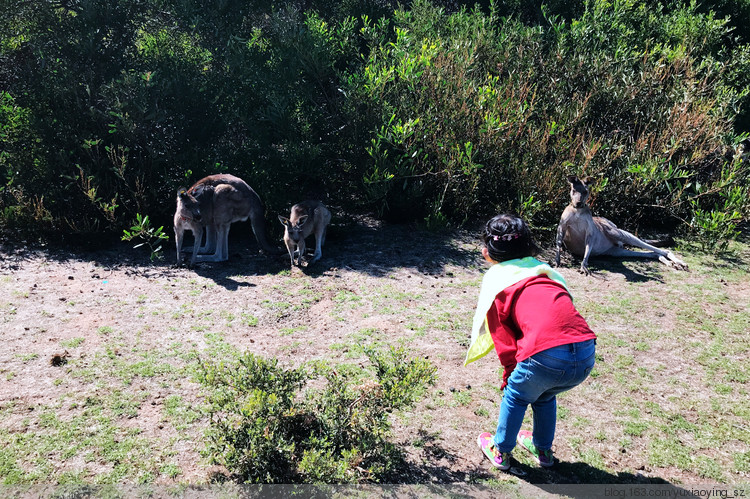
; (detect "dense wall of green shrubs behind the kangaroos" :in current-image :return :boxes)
[0,0,750,248]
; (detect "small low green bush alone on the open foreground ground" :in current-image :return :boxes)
[198,348,436,483]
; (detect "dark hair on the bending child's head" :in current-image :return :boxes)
[482,213,541,262]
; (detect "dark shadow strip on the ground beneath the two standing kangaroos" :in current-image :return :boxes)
[0,216,479,290]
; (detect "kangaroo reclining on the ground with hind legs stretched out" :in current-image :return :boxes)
[555,175,687,275]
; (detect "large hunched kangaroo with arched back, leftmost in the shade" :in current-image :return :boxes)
[174,174,278,265]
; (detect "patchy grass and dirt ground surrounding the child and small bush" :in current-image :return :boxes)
[0,227,750,486]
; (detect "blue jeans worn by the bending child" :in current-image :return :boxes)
[494,340,596,452]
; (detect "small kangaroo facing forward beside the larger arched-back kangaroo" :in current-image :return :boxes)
[279,201,331,266]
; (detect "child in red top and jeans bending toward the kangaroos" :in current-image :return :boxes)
[465,215,596,470]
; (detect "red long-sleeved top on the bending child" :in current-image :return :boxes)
[487,275,596,389]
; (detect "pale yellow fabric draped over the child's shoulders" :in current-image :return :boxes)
[464,256,570,366]
